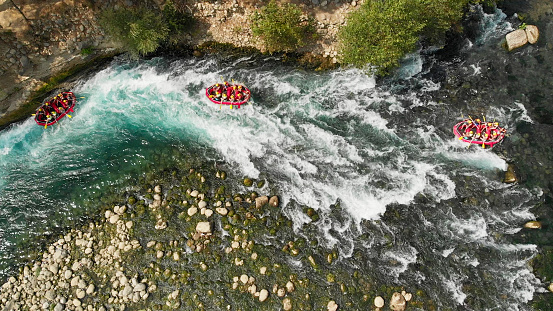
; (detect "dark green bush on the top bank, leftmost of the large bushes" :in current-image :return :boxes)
[100,1,192,57]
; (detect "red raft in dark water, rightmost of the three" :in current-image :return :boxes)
[453,119,506,148]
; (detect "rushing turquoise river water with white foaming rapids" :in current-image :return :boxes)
[0,6,541,310]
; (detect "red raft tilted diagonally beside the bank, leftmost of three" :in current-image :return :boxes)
[34,92,77,128]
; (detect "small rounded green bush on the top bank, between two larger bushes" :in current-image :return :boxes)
[251,0,315,53]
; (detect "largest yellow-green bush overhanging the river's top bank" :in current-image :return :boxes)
[338,0,470,75]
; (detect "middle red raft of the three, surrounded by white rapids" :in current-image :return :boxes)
[205,82,251,109]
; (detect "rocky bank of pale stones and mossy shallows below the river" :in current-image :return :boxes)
[0,165,426,311]
